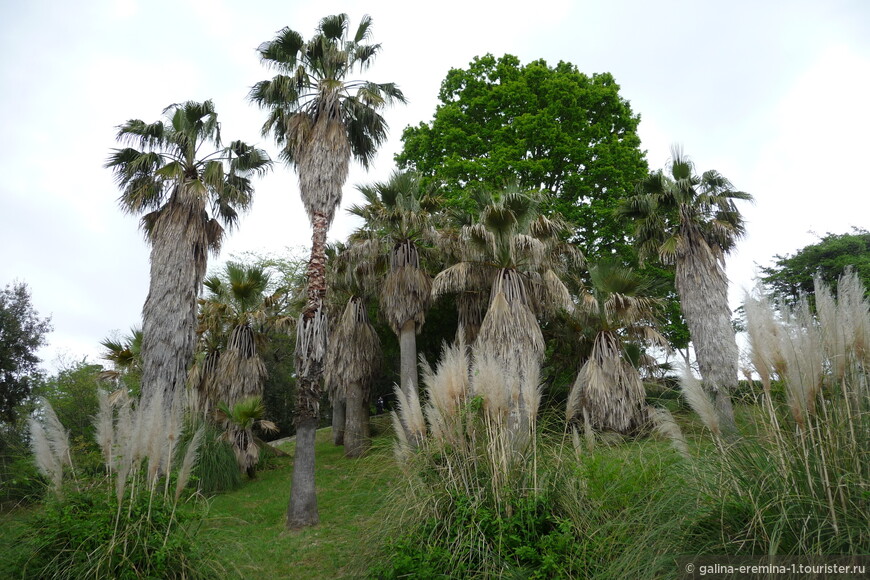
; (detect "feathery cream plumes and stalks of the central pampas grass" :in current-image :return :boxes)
[393,333,541,512]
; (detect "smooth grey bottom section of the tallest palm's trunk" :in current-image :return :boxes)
[287,417,320,529]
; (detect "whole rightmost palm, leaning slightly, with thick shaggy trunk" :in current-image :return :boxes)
[619,146,752,430]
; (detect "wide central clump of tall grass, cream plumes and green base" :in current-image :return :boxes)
[378,343,697,578]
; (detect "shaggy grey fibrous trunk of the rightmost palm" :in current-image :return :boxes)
[676,240,738,431]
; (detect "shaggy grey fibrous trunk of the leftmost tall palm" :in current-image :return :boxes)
[142,202,209,406]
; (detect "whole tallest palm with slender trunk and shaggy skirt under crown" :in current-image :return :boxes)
[250,14,405,528]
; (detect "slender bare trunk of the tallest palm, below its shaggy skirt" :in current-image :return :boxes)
[287,213,329,529]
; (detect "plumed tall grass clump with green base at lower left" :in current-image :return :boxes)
[19,392,218,578]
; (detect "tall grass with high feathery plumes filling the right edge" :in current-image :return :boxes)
[684,273,870,555]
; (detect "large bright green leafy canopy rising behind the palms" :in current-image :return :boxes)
[396,54,647,255]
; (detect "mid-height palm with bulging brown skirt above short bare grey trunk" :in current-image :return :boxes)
[348,171,440,406]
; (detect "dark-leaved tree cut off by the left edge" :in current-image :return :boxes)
[0,283,51,421]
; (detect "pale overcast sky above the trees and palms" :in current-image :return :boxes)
[0,0,870,369]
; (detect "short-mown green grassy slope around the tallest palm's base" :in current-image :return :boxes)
[206,422,404,579]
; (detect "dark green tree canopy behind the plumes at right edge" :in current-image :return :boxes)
[761,228,870,300]
